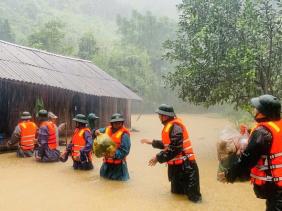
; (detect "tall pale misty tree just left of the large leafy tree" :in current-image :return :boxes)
[117,10,175,75]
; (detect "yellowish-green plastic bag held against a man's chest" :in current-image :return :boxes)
[93,134,116,158]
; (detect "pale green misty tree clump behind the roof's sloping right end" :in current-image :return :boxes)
[94,44,157,103]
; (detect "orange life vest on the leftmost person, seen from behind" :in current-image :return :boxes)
[18,121,37,150]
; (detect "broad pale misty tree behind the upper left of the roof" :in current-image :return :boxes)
[28,20,70,54]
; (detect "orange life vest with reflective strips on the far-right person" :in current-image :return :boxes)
[251,120,282,187]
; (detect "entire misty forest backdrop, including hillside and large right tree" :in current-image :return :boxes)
[0,0,282,113]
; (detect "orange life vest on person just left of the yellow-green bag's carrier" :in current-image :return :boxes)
[72,127,92,160]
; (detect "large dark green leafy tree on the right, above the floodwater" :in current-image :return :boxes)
[164,0,282,108]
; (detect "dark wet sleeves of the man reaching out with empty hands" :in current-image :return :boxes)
[152,124,183,163]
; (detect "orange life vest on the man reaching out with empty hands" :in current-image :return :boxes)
[162,118,195,165]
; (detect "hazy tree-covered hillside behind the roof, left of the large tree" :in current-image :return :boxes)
[0,0,180,111]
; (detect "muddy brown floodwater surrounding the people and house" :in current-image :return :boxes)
[0,114,265,211]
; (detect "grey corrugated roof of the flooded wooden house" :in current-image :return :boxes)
[0,40,142,100]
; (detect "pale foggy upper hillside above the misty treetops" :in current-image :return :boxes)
[0,0,179,44]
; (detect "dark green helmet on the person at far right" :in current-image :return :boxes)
[251,95,281,118]
